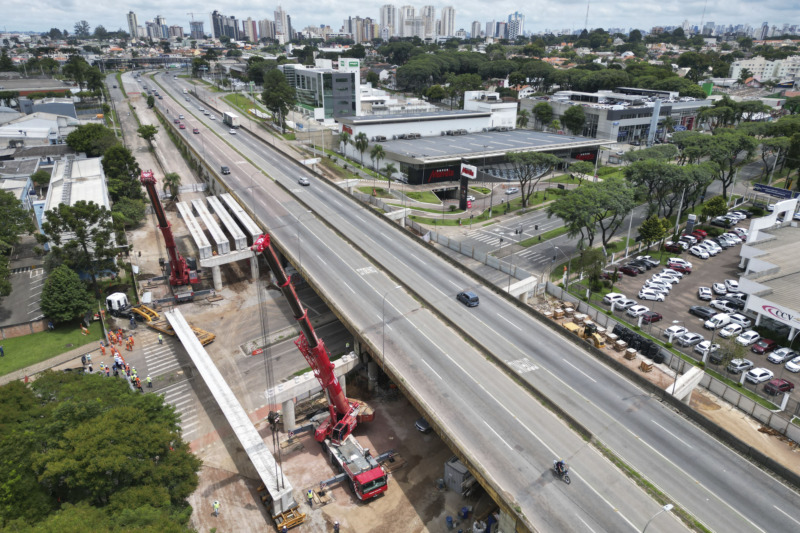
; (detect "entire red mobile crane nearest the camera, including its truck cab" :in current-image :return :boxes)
[250,235,388,500]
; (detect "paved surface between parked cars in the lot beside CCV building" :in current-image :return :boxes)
[613,221,800,412]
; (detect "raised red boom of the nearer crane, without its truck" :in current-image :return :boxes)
[250,235,372,444]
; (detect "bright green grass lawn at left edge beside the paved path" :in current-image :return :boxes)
[0,322,103,376]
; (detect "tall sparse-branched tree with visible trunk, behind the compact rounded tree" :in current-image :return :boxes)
[37,200,116,297]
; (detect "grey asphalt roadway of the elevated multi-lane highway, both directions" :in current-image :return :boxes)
[134,71,800,531]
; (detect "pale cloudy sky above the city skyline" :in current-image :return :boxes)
[0,0,800,33]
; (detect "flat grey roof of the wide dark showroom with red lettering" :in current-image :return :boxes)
[378,128,608,163]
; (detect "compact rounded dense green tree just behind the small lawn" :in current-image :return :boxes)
[41,265,94,323]
